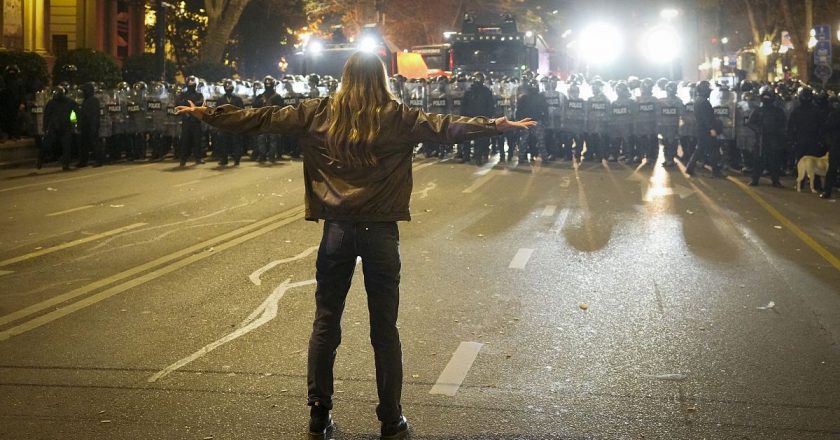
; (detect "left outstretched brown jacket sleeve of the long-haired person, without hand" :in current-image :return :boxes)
[201,100,320,135]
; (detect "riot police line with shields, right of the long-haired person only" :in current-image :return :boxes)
[392,72,840,197]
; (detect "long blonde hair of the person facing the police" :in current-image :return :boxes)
[326,51,394,167]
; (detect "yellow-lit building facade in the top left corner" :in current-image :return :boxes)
[0,0,145,60]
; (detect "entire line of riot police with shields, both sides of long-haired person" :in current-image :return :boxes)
[24,71,840,198]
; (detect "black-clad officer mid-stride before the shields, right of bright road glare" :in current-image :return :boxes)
[686,81,723,177]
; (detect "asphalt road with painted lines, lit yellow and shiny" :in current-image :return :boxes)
[0,152,840,440]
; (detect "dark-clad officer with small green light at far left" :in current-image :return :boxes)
[36,86,79,171]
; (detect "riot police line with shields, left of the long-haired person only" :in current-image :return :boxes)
[28,75,337,170]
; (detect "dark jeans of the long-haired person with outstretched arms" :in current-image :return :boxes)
[307,220,403,423]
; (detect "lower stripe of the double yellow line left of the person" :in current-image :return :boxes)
[0,207,304,341]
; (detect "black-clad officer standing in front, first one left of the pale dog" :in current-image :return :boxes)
[747,86,785,188]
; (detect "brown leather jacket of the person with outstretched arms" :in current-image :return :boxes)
[202,98,499,222]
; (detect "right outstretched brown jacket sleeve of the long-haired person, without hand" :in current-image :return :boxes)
[400,104,499,144]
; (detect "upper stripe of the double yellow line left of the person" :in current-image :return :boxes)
[0,206,303,325]
